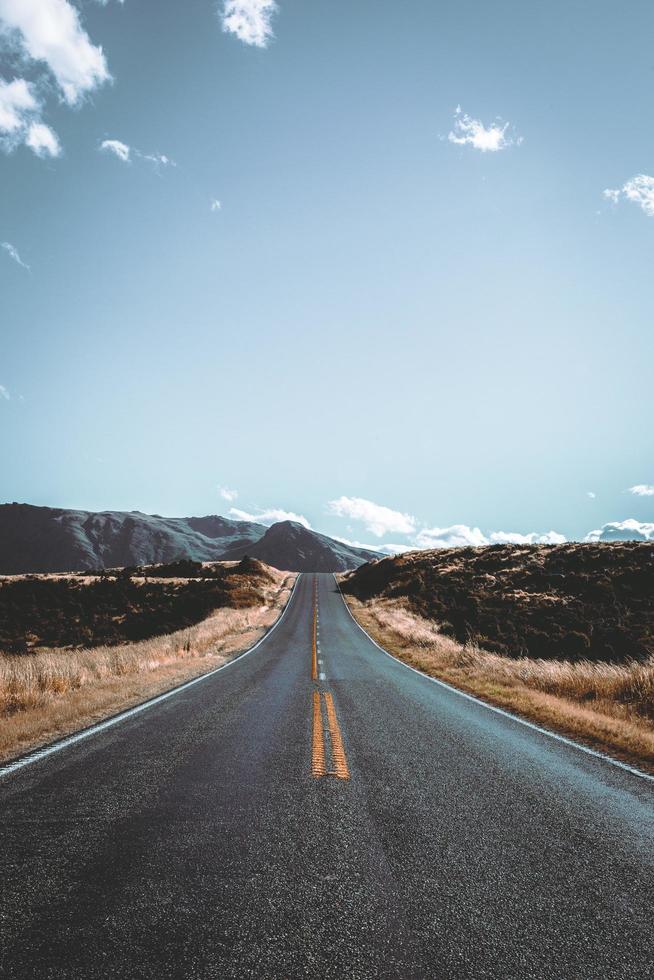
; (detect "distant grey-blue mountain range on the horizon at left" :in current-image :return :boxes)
[0,503,379,575]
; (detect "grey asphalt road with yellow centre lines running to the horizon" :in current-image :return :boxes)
[0,575,654,980]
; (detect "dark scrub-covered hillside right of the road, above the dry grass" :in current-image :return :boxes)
[343,542,654,663]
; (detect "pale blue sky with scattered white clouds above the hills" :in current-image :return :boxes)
[0,0,654,546]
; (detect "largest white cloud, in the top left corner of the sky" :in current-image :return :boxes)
[0,0,111,105]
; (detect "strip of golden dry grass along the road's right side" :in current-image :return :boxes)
[344,596,654,772]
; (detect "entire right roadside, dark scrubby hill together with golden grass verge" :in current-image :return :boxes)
[341,543,654,771]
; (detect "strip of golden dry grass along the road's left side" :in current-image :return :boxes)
[0,569,296,759]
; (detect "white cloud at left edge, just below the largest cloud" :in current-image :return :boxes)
[0,78,61,157]
